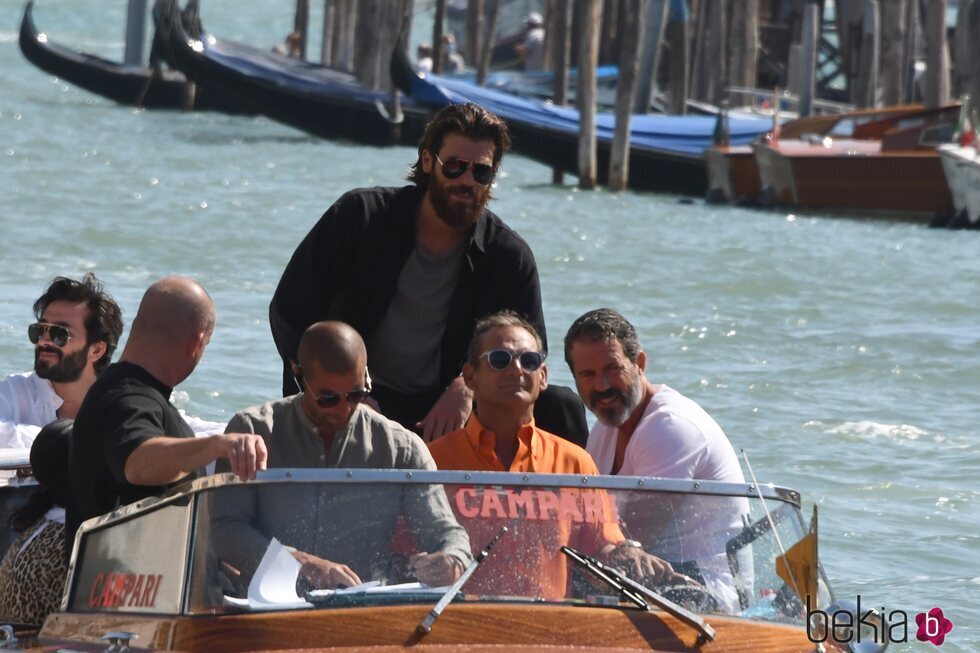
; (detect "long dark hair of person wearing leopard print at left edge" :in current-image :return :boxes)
[7,419,74,533]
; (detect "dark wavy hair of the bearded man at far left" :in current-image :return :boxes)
[34,272,123,374]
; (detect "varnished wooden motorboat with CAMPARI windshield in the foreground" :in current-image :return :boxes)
[1,469,856,653]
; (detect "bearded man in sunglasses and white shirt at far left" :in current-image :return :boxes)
[0,273,123,448]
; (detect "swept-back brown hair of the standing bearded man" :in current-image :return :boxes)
[408,102,510,189]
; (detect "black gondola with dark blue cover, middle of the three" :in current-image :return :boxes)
[169,6,429,145]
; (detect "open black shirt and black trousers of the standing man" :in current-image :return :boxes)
[269,186,589,446]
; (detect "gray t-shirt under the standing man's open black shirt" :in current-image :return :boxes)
[368,243,463,394]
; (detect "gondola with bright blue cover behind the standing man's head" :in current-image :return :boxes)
[391,41,772,196]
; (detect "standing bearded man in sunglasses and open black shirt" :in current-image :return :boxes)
[269,104,588,443]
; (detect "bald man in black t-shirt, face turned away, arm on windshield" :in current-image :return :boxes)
[65,277,266,555]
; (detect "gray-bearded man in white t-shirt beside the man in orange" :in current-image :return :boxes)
[565,308,748,609]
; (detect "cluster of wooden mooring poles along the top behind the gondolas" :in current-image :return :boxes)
[222,0,980,189]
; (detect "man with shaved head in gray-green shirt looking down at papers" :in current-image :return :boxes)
[211,322,472,588]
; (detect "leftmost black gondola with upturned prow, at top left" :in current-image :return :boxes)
[20,0,243,113]
